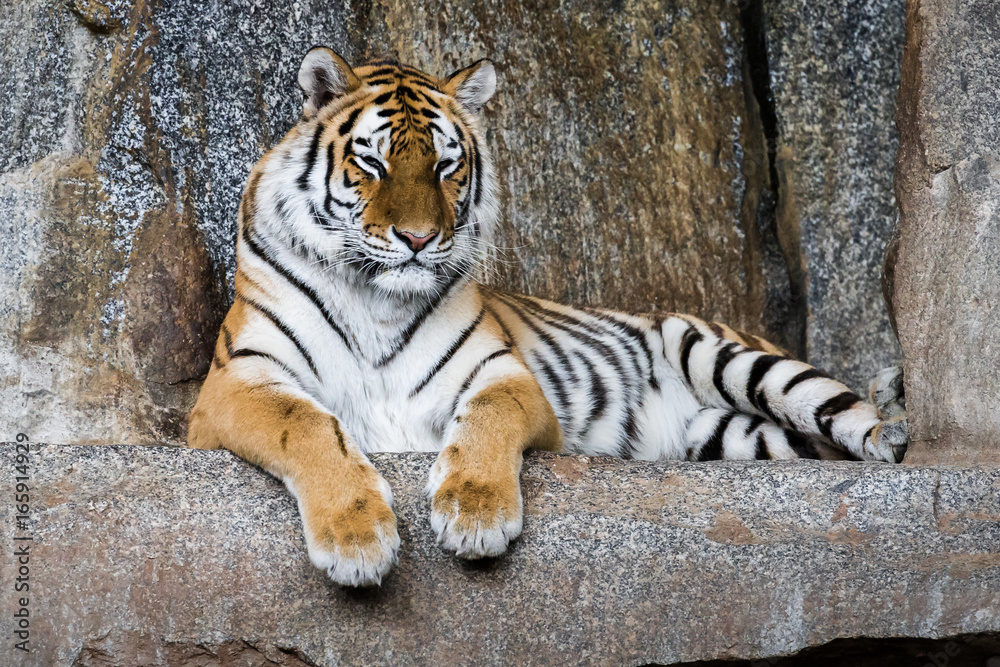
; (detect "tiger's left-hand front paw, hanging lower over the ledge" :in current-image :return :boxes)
[289,471,399,586]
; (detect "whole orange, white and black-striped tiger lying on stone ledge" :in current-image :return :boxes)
[188,47,907,587]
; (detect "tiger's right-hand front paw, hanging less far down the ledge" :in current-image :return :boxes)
[425,445,522,559]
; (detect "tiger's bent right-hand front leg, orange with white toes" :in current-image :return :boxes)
[426,369,562,558]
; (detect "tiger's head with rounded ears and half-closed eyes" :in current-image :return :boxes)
[251,47,497,296]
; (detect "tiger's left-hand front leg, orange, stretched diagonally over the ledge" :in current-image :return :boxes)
[188,357,399,586]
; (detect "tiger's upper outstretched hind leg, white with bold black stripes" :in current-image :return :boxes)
[662,315,907,462]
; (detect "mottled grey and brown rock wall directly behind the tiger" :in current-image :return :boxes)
[0,0,908,443]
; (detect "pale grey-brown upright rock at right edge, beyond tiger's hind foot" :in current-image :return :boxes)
[887,0,1000,463]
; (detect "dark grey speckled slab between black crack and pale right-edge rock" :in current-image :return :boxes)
[763,0,904,391]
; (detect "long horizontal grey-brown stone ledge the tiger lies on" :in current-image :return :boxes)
[0,445,1000,667]
